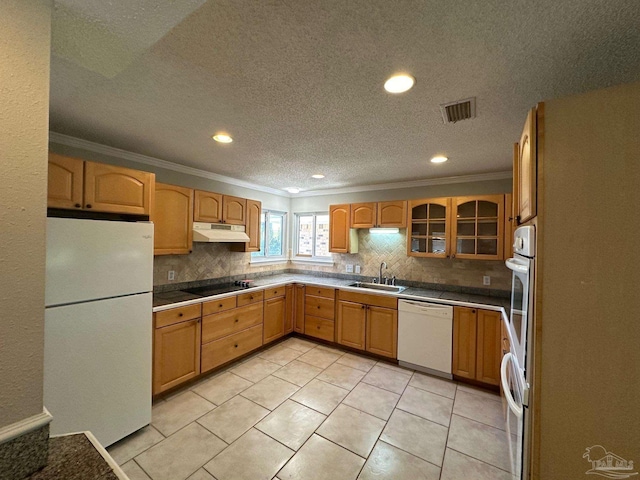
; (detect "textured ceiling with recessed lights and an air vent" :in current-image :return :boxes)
[50,0,640,191]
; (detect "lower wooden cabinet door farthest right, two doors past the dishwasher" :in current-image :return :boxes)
[476,310,502,385]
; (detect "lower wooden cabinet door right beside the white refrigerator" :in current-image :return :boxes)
[153,318,200,395]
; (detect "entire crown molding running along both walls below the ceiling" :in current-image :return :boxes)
[49,132,513,198]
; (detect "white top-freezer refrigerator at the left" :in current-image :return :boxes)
[44,218,153,446]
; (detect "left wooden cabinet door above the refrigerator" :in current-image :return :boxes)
[47,152,84,209]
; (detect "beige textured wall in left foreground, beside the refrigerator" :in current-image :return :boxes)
[0,0,51,427]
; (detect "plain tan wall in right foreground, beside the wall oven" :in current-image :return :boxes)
[536,83,640,479]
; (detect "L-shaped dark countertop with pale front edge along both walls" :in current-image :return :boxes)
[153,273,510,311]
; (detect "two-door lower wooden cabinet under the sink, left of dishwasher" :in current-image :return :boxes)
[336,290,398,358]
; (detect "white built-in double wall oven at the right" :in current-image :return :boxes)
[500,225,536,479]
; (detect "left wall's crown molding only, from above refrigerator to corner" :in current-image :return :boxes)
[49,131,291,198]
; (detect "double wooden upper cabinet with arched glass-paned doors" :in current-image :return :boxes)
[407,195,504,260]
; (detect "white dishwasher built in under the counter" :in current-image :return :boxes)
[398,300,453,378]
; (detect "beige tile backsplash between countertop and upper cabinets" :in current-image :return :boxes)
[153,229,511,291]
